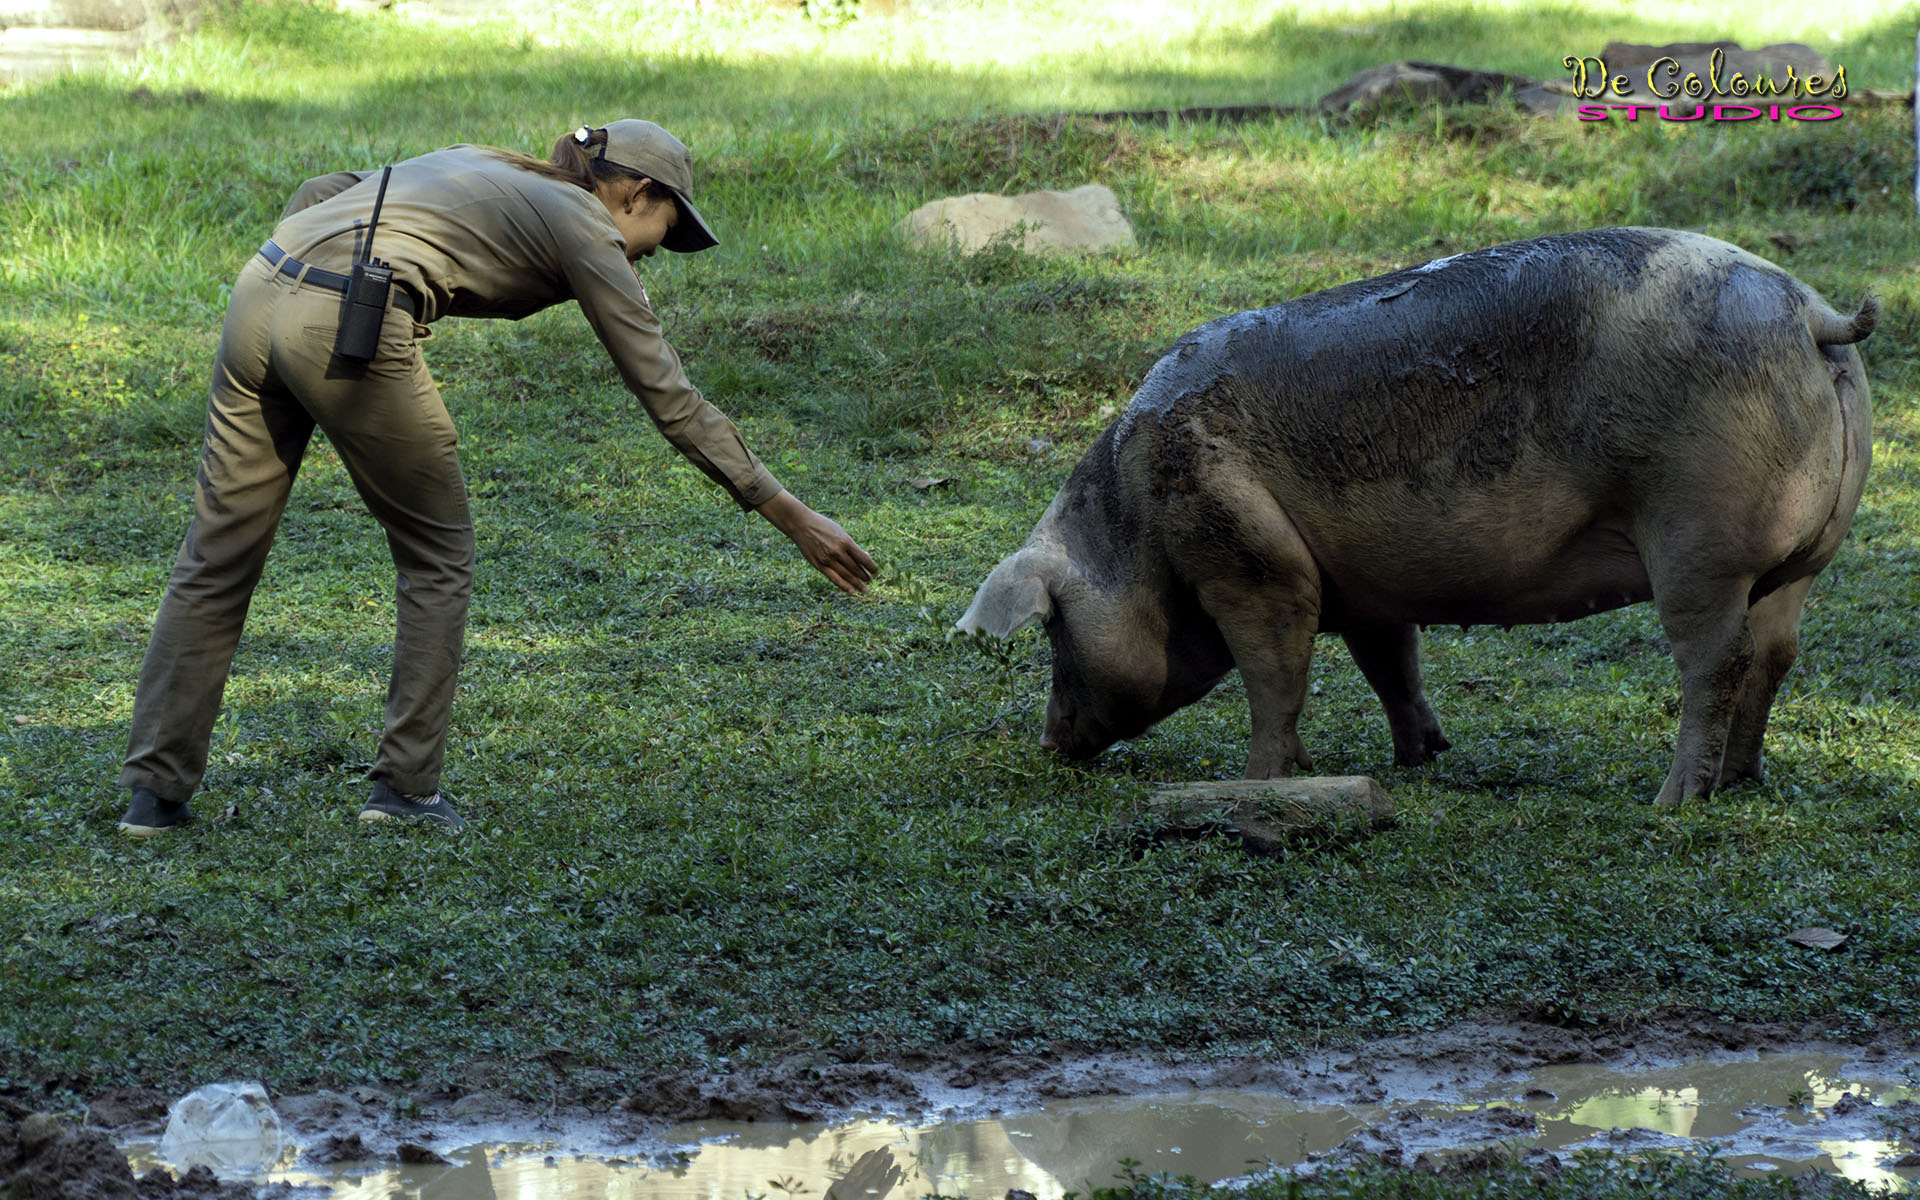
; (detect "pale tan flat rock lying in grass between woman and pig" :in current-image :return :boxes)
[900,182,1135,253]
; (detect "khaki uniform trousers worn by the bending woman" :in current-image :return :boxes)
[121,255,474,801]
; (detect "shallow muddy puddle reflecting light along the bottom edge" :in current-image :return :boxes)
[125,1052,1920,1200]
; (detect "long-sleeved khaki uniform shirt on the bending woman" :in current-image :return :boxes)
[273,146,780,509]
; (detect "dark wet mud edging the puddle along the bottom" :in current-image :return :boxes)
[15,1018,1920,1200]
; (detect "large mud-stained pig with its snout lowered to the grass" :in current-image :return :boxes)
[954,228,1876,804]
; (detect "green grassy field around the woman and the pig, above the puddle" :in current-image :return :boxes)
[0,0,1920,1144]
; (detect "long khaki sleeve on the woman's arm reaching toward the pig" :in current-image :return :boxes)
[563,238,781,509]
